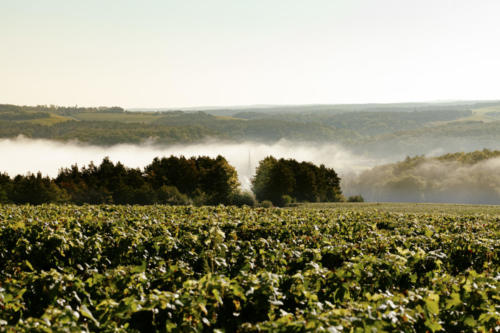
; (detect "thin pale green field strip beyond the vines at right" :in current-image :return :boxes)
[299,202,500,216]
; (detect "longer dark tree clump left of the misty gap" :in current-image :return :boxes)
[0,156,239,205]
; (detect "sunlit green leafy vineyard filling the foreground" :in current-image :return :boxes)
[0,205,500,332]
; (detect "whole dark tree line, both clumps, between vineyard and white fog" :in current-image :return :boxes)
[0,156,342,206]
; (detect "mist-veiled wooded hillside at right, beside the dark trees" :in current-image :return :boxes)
[345,150,500,204]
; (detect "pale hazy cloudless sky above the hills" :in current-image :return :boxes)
[0,0,500,107]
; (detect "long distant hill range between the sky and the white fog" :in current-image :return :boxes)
[0,101,500,156]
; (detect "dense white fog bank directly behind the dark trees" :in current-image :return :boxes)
[0,137,378,189]
